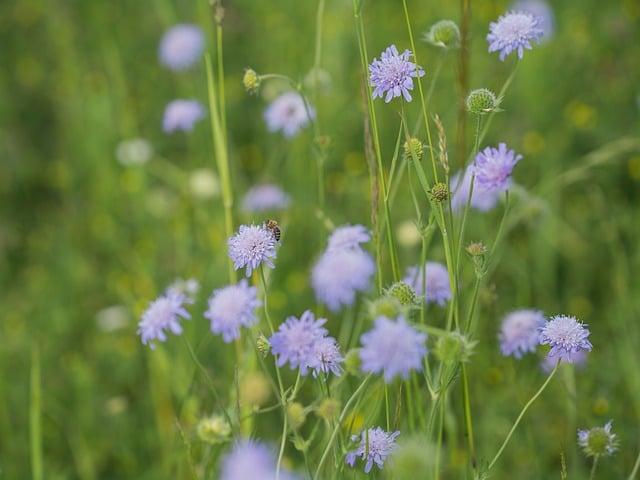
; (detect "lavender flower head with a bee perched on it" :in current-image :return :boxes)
[227,225,276,277]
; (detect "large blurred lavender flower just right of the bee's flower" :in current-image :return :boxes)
[311,249,376,312]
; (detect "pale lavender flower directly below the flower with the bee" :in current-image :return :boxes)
[204,278,261,343]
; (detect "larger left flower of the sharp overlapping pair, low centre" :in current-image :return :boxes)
[269,310,327,375]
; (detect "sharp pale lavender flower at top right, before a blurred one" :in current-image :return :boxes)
[487,12,544,61]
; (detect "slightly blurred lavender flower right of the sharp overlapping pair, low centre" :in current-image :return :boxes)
[360,317,427,383]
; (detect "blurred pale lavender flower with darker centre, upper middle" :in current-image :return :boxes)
[264,91,315,138]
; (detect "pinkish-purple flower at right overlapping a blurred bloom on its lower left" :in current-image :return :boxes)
[473,143,522,192]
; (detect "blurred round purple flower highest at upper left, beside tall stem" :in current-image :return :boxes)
[158,23,204,70]
